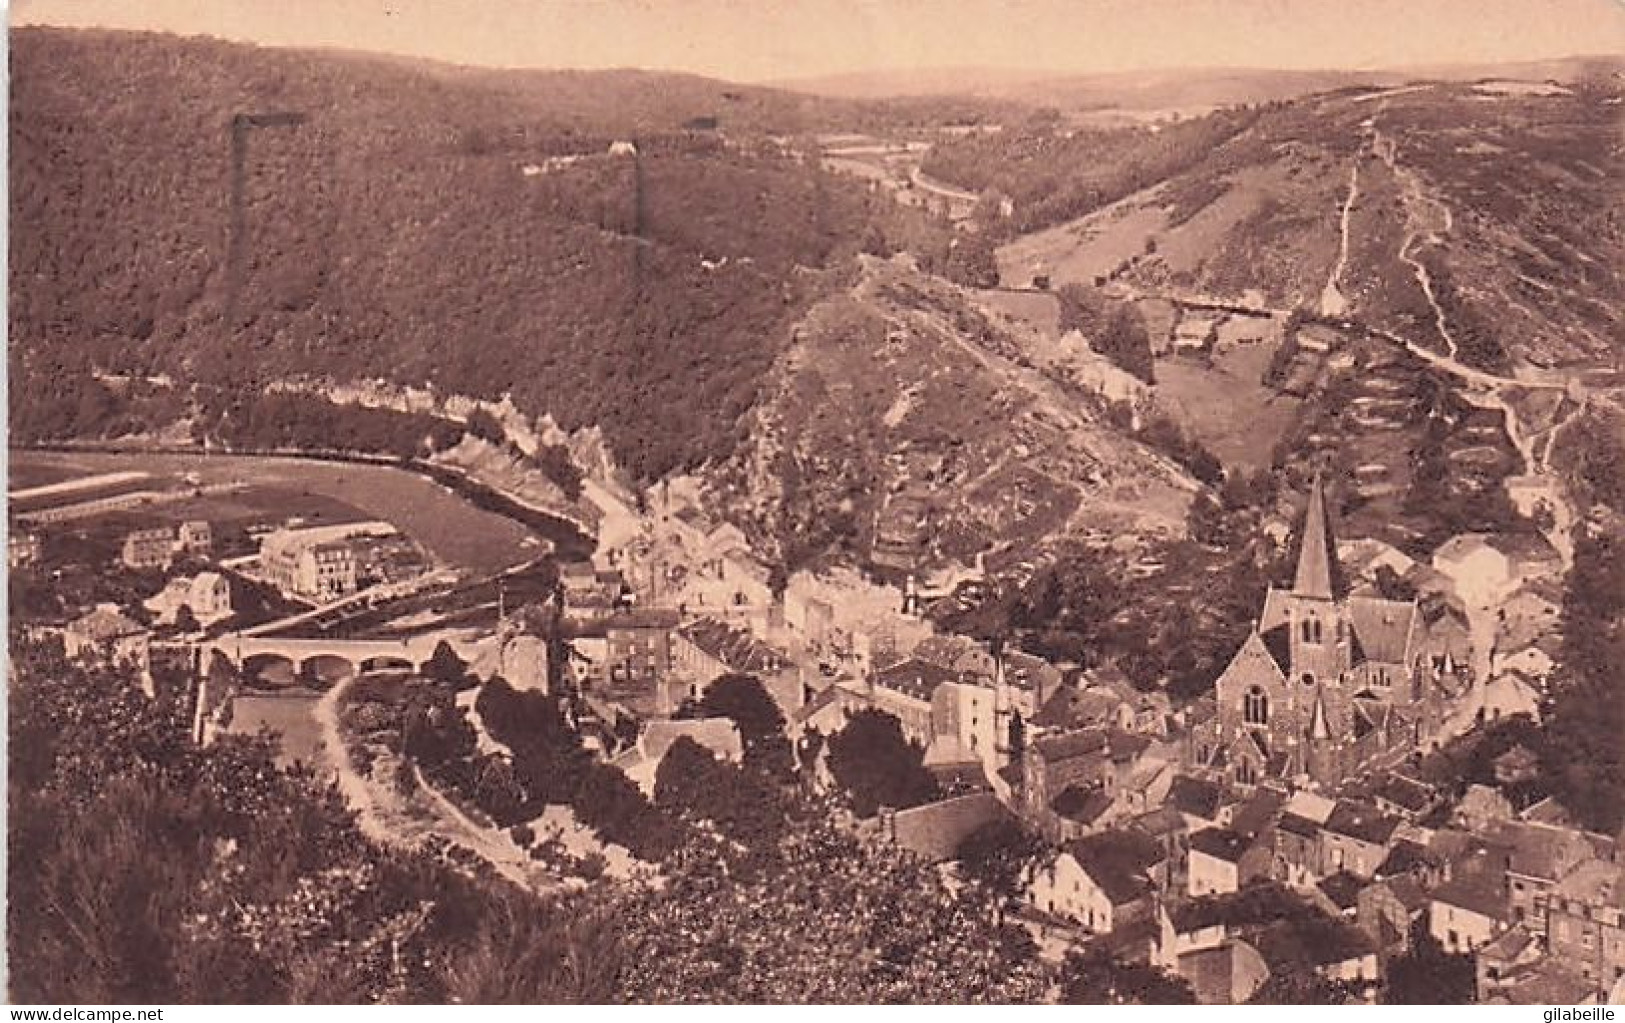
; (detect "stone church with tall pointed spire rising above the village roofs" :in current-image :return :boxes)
[1190,476,1467,786]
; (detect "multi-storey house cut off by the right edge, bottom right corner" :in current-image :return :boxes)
[1547,859,1625,994]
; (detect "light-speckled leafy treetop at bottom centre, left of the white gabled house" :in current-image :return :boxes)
[622,818,1048,1004]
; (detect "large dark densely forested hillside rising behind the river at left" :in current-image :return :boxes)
[10,29,952,479]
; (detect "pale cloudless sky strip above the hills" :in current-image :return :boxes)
[11,0,1625,81]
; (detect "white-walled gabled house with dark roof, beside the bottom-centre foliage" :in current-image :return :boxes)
[1029,831,1164,934]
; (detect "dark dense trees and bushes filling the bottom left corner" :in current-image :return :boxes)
[7,637,614,1004]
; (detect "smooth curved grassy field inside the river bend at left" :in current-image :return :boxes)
[11,451,538,573]
